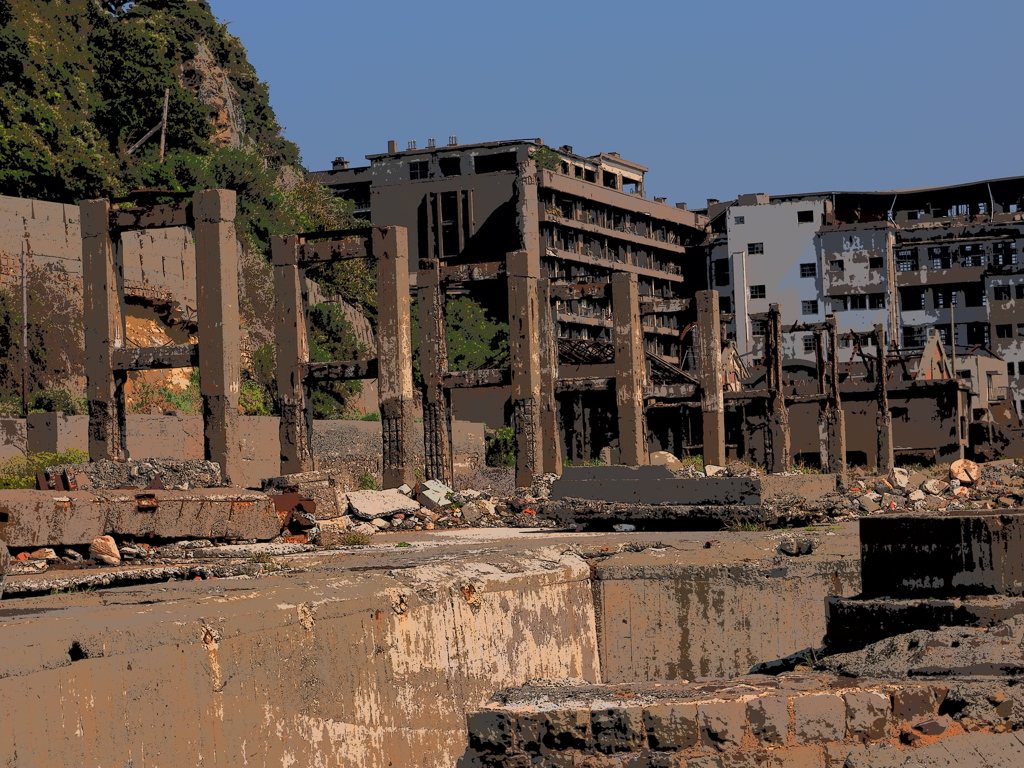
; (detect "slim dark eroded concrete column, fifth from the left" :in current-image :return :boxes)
[416,259,454,485]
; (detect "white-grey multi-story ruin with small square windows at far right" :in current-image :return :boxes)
[708,177,1024,412]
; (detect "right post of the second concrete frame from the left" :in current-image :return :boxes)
[373,226,416,487]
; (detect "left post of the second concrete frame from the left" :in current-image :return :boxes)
[270,234,313,474]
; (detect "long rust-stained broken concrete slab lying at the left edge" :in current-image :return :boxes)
[0,488,281,547]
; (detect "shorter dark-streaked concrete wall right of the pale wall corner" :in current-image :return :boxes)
[595,541,860,683]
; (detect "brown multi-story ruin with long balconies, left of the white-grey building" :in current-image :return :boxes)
[311,137,708,362]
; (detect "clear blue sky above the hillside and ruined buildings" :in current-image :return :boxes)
[211,0,1024,207]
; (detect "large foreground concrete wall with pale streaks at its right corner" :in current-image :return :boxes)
[0,551,600,768]
